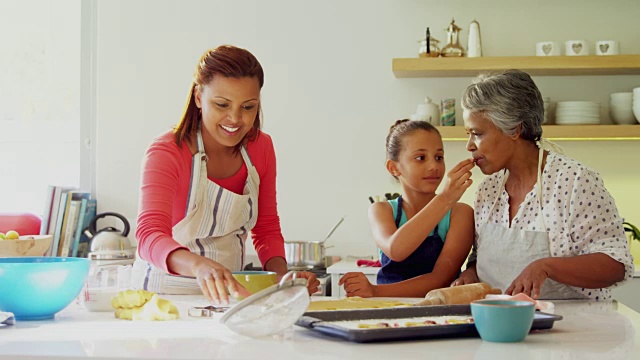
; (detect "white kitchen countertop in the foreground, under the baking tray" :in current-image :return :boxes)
[0,296,640,360]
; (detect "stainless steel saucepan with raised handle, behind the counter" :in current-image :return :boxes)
[284,216,344,268]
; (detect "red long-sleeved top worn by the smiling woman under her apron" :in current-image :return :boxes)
[136,131,285,272]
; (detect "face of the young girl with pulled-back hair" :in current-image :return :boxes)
[389,130,445,193]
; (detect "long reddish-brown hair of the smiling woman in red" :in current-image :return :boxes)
[173,45,264,150]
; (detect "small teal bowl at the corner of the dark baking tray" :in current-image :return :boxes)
[471,300,535,342]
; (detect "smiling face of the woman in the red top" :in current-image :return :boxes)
[195,76,260,147]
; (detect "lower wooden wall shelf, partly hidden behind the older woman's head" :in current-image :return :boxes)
[437,124,640,141]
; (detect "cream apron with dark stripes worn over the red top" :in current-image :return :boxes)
[132,131,260,294]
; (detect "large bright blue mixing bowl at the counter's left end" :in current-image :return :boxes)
[0,257,89,320]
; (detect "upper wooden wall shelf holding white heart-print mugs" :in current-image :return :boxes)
[393,55,640,78]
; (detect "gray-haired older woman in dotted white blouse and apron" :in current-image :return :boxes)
[452,70,634,300]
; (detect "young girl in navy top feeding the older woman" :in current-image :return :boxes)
[339,119,474,297]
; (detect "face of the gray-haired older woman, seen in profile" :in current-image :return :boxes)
[463,110,513,175]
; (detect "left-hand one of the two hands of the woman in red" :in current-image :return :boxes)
[193,257,251,306]
